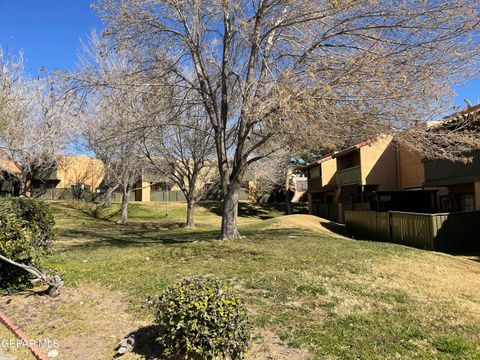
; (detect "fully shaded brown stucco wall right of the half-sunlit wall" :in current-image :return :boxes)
[398,145,425,189]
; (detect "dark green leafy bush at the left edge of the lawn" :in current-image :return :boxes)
[0,198,55,290]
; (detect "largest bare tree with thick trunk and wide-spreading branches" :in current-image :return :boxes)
[97,0,479,239]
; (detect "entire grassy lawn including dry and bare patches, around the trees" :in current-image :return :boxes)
[0,203,480,359]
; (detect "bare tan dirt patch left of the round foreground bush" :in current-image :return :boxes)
[0,285,142,360]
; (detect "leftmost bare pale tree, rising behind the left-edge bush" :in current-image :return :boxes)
[0,63,71,196]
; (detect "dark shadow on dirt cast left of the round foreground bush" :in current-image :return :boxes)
[117,325,168,360]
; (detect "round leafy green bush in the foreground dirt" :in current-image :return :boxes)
[155,278,251,359]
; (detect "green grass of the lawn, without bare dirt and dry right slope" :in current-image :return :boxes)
[40,202,480,359]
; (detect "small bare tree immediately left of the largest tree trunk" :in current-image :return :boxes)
[145,103,216,228]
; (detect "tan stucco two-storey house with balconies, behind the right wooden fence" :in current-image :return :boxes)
[304,136,441,222]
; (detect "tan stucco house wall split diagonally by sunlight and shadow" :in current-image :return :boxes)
[360,136,399,191]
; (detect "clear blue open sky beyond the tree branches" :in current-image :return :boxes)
[0,0,480,107]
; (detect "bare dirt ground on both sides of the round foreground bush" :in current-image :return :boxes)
[0,285,307,360]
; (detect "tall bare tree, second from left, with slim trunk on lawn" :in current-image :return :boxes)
[66,33,154,224]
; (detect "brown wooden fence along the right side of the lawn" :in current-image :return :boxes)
[345,211,480,252]
